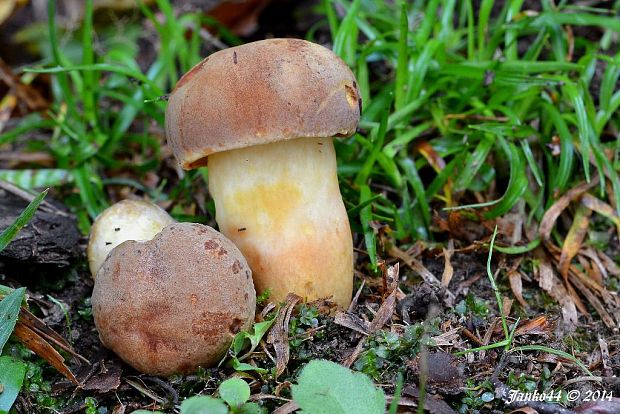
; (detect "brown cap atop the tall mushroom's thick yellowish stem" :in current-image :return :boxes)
[166,39,361,169]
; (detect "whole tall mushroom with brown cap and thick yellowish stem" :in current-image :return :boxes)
[166,39,361,307]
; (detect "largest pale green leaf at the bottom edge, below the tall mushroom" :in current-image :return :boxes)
[292,360,385,414]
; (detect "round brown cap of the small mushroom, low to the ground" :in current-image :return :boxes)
[92,223,256,376]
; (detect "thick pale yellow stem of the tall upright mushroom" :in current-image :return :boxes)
[208,138,353,307]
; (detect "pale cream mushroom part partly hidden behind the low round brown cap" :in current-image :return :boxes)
[86,200,175,278]
